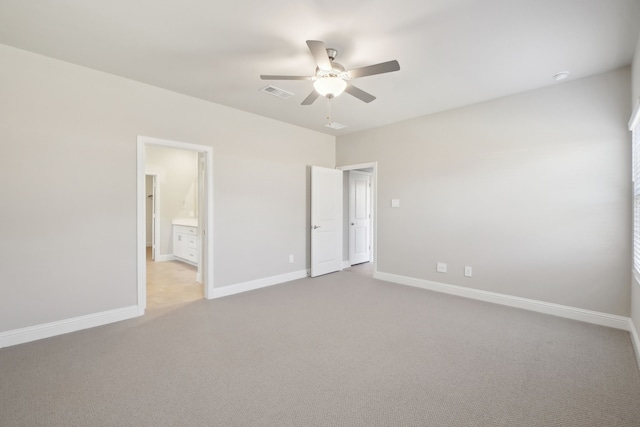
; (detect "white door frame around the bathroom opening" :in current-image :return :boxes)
[136,135,213,315]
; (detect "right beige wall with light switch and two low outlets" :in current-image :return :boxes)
[336,68,631,316]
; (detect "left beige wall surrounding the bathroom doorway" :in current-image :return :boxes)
[0,45,335,332]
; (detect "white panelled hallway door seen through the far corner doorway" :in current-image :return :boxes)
[349,171,371,265]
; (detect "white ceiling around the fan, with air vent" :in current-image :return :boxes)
[0,0,640,135]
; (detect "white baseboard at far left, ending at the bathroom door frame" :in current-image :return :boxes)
[0,305,144,348]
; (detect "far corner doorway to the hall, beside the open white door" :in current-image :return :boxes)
[337,162,378,276]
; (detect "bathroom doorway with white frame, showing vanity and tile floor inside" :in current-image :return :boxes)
[138,137,213,313]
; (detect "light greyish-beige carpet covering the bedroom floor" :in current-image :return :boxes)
[0,272,640,427]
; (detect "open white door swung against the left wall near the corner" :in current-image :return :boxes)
[311,166,342,277]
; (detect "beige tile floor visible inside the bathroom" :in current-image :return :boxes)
[147,248,204,310]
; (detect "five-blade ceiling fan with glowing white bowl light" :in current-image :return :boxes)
[260,40,400,105]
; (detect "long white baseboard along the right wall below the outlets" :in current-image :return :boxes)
[373,271,638,332]
